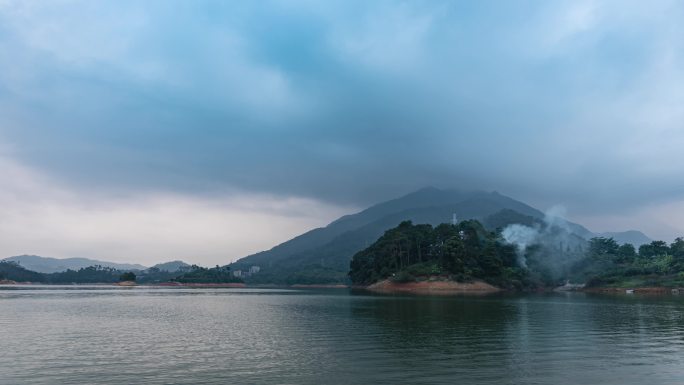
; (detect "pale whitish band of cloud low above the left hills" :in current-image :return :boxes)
[0,155,351,265]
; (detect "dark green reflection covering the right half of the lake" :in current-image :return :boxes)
[352,293,684,384]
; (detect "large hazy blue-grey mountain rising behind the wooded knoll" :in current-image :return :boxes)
[232,187,650,283]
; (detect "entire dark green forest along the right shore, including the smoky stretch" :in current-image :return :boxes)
[349,220,684,289]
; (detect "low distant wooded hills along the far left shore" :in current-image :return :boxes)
[0,261,242,284]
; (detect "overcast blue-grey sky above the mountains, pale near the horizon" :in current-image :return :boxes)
[0,0,684,265]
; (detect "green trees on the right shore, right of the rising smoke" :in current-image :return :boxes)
[571,238,684,287]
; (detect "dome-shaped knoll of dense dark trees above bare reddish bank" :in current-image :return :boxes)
[349,220,532,288]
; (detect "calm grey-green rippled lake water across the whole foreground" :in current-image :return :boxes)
[0,287,684,385]
